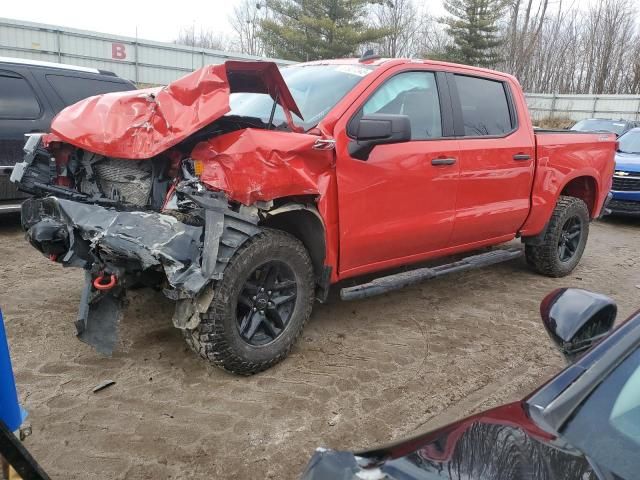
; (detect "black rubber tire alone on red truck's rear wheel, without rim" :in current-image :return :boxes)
[525,195,589,277]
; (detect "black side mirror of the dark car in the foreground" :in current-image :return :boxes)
[540,288,618,363]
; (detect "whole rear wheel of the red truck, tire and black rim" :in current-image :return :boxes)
[525,196,589,277]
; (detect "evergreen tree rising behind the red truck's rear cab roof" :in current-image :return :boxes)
[441,0,507,67]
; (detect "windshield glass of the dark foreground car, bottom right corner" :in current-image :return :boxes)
[562,349,640,478]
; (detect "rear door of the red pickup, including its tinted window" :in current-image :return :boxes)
[448,72,535,246]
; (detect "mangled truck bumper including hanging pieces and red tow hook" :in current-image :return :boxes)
[22,192,259,354]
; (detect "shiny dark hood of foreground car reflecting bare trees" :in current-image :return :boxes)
[302,402,596,480]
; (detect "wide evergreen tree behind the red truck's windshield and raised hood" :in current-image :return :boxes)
[261,0,388,61]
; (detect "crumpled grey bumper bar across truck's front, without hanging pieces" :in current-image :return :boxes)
[22,197,207,296]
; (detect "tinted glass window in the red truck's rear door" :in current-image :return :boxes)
[454,75,515,137]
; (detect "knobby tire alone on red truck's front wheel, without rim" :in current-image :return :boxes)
[183,228,315,375]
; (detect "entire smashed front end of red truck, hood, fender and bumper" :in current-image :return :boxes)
[11,62,331,354]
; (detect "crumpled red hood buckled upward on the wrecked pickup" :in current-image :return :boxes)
[51,61,302,160]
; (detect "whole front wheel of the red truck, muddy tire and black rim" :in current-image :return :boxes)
[184,229,314,375]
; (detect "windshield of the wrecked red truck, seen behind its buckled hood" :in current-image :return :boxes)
[228,65,374,130]
